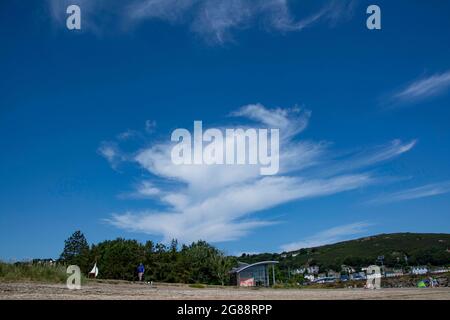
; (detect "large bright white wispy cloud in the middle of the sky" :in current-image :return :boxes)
[101,104,413,242]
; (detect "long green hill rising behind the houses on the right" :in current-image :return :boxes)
[239,233,450,271]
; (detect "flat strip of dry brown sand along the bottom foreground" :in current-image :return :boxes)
[0,282,450,300]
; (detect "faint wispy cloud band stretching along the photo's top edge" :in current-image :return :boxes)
[48,0,355,43]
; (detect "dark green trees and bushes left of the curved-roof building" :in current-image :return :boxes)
[60,231,237,285]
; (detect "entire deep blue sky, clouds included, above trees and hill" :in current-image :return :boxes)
[0,0,450,260]
